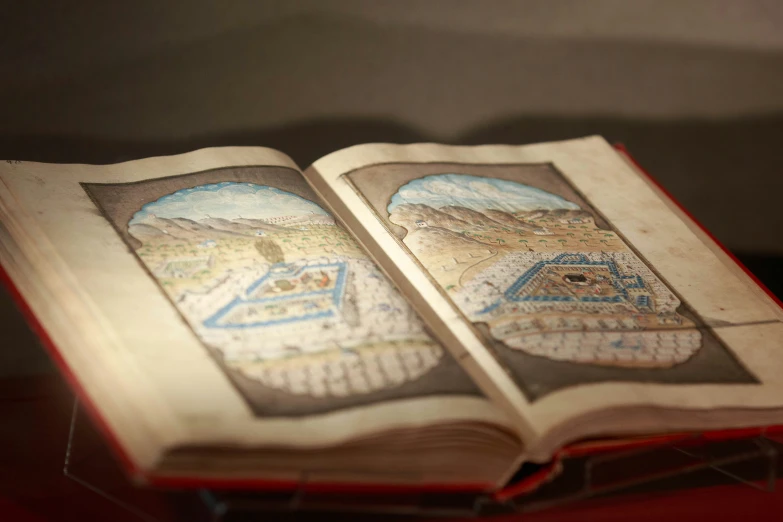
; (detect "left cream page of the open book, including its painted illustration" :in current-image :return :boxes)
[0,148,511,472]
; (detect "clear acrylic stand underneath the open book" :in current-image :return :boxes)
[63,402,783,522]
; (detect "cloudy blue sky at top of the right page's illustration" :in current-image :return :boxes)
[387,174,579,213]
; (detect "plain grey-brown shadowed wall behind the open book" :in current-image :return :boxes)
[0,0,783,373]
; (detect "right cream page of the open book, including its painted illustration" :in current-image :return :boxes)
[305,138,783,450]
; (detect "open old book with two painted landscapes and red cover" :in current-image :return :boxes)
[0,137,783,490]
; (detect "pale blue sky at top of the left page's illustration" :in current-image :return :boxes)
[129,182,328,225]
